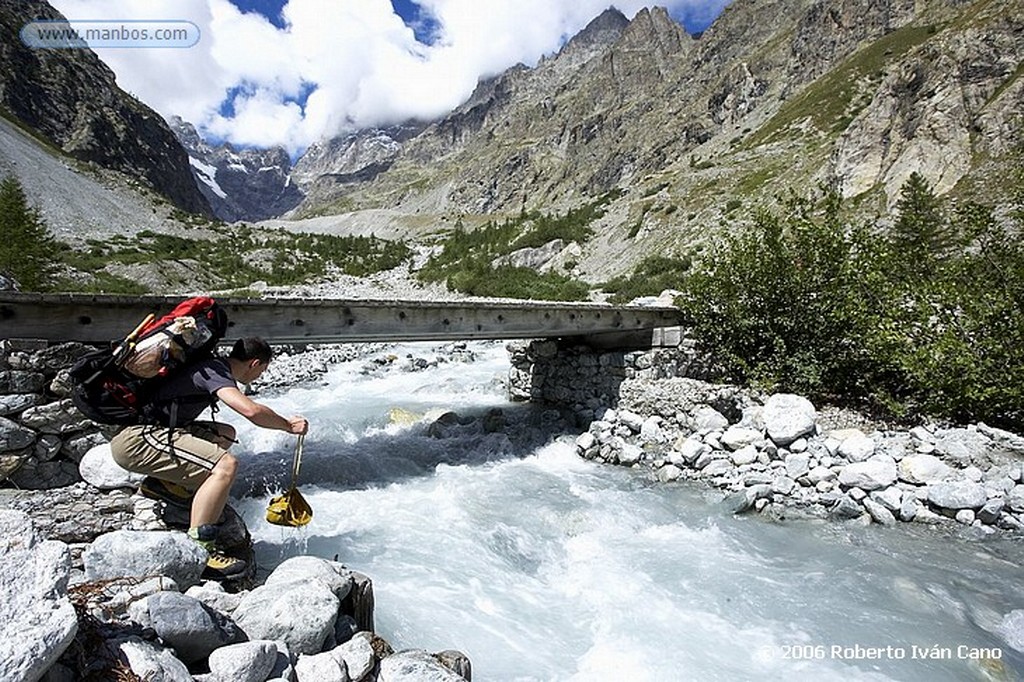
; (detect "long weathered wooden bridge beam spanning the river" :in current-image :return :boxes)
[0,292,681,349]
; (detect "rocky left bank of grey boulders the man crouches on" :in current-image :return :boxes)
[0,341,472,682]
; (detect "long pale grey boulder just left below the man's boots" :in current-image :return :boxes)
[82,530,207,588]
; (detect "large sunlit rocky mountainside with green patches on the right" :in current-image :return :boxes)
[292,0,1024,282]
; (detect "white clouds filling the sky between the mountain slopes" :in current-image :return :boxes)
[51,0,729,155]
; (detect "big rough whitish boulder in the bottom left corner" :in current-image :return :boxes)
[0,509,78,680]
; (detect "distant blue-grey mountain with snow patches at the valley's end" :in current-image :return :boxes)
[170,116,302,222]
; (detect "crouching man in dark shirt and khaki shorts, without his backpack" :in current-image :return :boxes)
[111,337,309,579]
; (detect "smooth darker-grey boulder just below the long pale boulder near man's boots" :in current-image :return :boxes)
[145,592,246,659]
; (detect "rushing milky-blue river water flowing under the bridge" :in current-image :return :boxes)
[222,344,1024,682]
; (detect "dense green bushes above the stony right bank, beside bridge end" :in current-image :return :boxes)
[677,177,1024,429]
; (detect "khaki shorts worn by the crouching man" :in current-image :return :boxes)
[111,422,227,491]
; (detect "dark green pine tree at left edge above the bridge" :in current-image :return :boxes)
[0,175,57,291]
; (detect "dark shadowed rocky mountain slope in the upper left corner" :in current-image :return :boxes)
[0,0,210,214]
